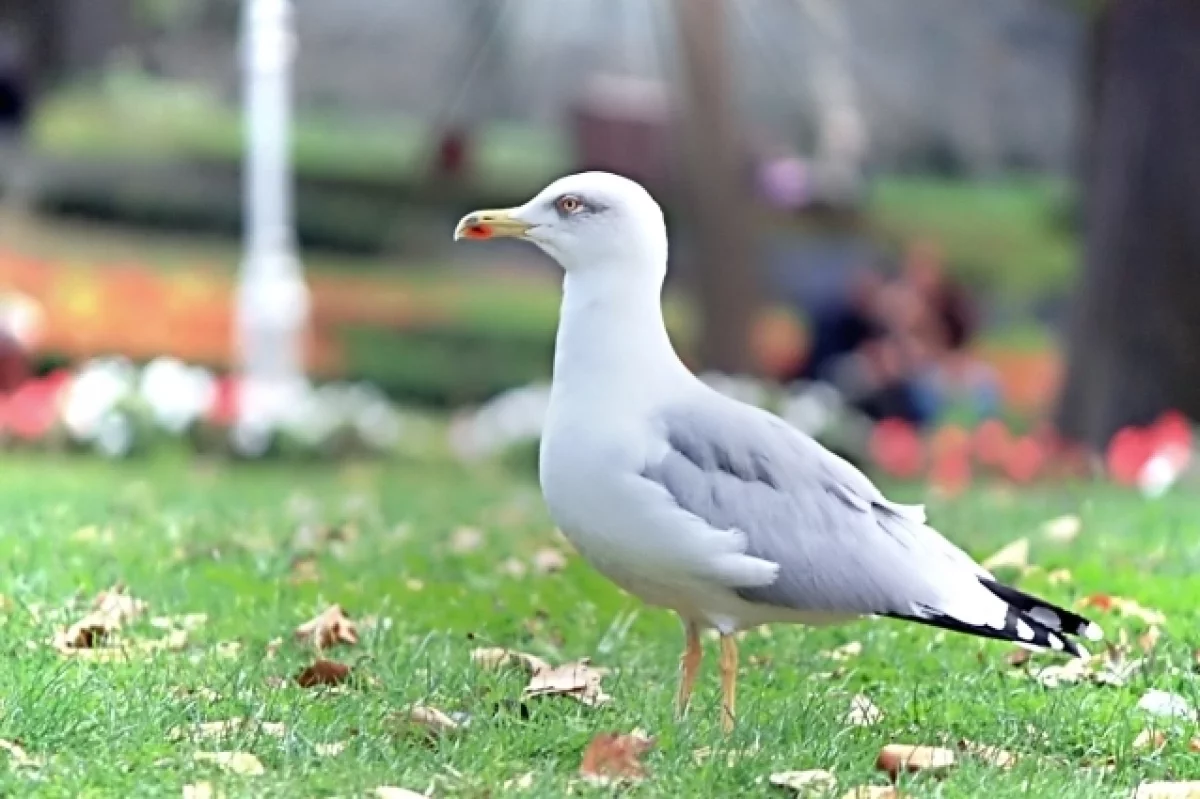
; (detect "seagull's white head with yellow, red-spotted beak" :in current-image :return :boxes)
[454,172,667,280]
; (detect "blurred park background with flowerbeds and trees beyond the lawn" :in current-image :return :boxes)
[0,0,1200,491]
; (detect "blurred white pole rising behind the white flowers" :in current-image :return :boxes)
[235,0,308,451]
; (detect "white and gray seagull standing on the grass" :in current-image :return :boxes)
[454,172,1103,732]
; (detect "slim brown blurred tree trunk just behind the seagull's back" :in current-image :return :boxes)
[674,0,758,374]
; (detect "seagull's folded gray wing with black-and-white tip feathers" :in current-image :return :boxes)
[643,392,1088,648]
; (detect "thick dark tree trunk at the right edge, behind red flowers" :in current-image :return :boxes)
[1057,0,1200,447]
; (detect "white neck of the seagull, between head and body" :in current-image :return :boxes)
[554,269,689,396]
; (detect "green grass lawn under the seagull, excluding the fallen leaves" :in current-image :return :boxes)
[0,458,1200,799]
